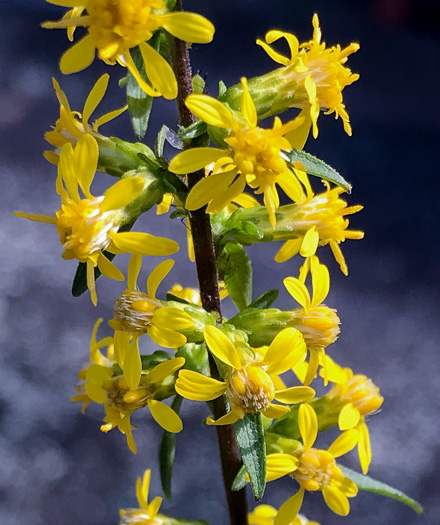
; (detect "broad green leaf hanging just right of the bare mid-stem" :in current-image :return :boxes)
[218,241,252,310]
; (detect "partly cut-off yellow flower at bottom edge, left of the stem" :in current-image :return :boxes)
[119,469,163,525]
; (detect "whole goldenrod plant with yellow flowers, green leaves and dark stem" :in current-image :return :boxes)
[16,4,421,525]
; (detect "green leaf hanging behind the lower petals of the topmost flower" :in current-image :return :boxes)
[126,31,160,139]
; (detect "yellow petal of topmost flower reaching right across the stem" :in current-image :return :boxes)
[160,12,215,44]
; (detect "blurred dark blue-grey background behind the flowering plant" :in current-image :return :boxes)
[0,0,440,525]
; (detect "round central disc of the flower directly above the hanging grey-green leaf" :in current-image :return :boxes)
[227,363,275,414]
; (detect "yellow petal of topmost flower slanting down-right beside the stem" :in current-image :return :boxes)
[139,42,177,100]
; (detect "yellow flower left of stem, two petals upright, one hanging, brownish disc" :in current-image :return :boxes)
[109,255,193,388]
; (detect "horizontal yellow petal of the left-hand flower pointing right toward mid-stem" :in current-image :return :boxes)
[112,232,179,255]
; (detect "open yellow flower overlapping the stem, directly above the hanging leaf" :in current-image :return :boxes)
[175,326,315,425]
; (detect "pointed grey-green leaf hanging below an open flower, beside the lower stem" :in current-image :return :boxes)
[232,414,266,500]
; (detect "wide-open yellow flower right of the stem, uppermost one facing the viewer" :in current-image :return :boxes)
[169,78,305,227]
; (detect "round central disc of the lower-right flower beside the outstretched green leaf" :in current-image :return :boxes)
[290,448,343,491]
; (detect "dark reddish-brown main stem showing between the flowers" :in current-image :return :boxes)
[174,4,248,525]
